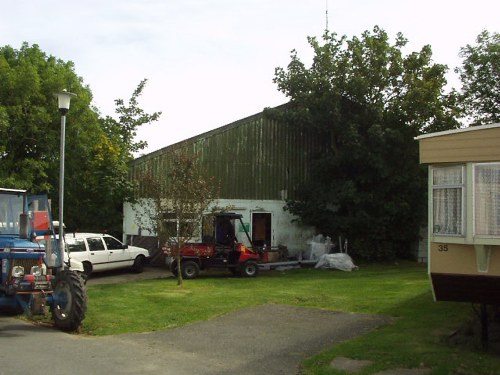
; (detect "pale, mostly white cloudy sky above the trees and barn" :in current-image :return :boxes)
[0,0,500,154]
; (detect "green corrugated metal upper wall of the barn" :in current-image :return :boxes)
[130,113,320,200]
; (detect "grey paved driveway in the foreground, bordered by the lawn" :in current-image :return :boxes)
[0,268,390,375]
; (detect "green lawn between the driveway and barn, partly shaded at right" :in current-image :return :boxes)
[83,263,500,375]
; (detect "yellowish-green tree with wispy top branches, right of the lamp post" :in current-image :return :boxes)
[67,80,161,235]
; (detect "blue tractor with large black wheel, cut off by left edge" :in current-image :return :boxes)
[0,188,87,331]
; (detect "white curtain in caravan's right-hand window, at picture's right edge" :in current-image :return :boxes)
[474,163,500,236]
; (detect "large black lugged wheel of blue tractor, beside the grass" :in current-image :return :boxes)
[51,271,87,331]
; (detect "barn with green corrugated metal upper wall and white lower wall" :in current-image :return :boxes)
[123,106,320,253]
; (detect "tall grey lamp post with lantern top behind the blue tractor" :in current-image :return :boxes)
[53,90,76,267]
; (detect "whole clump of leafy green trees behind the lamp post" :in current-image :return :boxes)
[0,43,160,232]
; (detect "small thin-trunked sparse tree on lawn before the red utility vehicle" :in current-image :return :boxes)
[133,148,218,286]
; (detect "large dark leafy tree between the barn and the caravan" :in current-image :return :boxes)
[271,27,458,259]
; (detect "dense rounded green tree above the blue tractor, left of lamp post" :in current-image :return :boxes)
[0,43,93,194]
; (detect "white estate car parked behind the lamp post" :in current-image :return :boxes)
[64,233,149,278]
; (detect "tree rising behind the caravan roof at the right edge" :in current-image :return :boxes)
[455,30,500,125]
